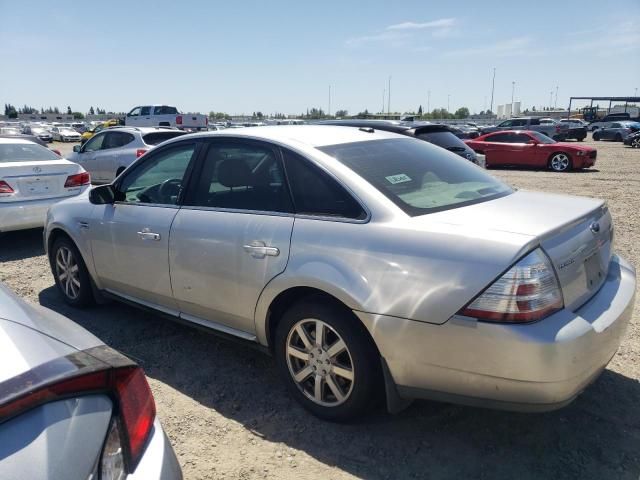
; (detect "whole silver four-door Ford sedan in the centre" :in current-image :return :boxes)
[45,126,636,420]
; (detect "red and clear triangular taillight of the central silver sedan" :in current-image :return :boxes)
[460,248,563,323]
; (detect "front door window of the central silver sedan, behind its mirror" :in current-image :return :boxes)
[117,144,195,205]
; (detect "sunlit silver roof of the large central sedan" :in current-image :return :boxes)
[176,125,398,147]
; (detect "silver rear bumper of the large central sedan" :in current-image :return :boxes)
[356,256,636,411]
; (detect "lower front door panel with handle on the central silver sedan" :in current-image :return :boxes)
[90,203,178,311]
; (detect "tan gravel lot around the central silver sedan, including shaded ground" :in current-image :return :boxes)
[0,137,640,480]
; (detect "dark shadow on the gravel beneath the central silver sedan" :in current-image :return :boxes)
[39,287,640,480]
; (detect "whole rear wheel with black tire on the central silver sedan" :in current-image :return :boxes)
[274,296,382,422]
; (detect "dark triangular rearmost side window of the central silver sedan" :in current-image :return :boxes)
[283,150,366,219]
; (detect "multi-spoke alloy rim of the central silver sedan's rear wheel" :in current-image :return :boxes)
[286,318,355,407]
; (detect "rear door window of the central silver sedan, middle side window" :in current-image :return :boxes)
[185,142,292,212]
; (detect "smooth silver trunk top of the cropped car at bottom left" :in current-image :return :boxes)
[0,284,103,382]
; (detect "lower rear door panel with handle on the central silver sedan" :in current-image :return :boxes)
[169,207,294,333]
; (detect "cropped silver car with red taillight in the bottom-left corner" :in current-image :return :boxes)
[0,284,182,480]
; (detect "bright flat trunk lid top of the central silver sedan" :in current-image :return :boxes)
[420,190,604,241]
